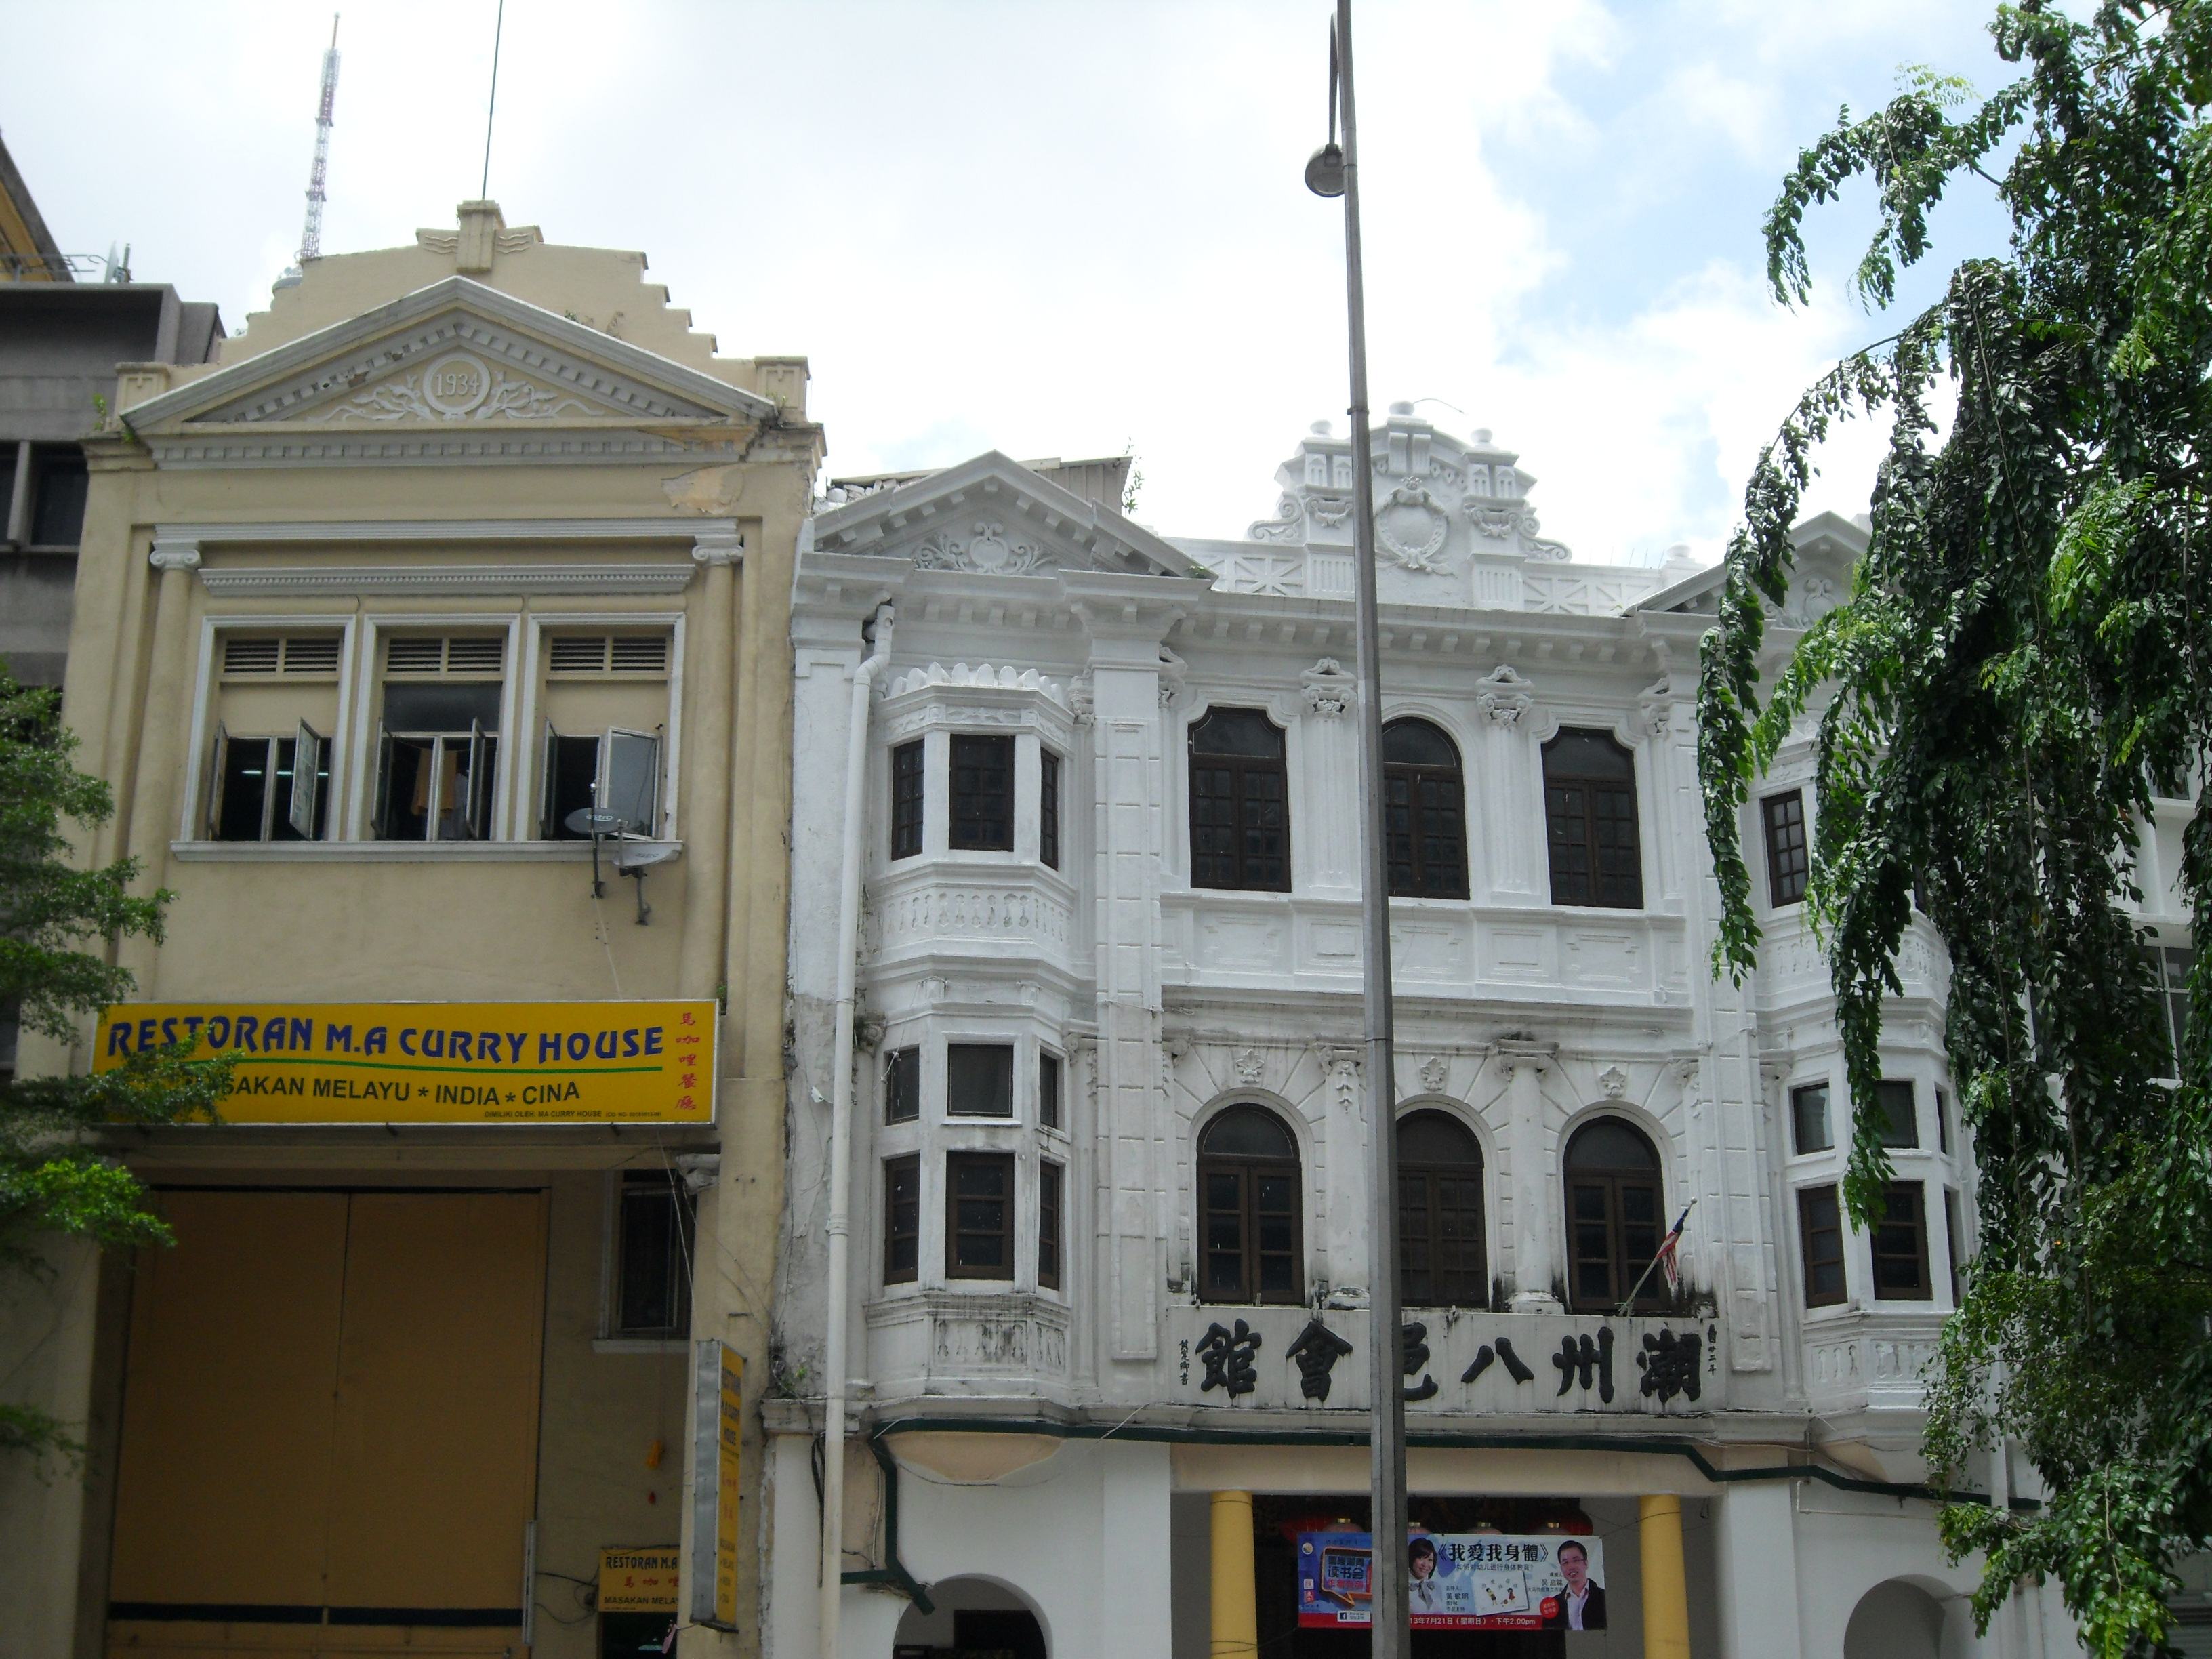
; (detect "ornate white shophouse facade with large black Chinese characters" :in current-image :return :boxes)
[765,405,2072,1659]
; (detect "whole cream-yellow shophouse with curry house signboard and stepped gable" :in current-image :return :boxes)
[0,201,823,1659]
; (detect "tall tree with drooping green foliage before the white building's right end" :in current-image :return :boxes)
[1699,0,2212,1659]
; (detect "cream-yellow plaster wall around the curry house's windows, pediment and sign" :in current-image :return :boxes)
[0,204,823,1659]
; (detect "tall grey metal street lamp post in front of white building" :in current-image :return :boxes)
[1305,0,1411,1659]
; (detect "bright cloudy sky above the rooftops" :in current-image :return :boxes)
[0,0,2006,562]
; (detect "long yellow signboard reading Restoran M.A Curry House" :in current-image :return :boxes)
[93,1002,714,1124]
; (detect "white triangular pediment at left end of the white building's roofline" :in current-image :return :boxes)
[814,449,1201,577]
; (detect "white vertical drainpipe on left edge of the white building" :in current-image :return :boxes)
[821,604,891,1659]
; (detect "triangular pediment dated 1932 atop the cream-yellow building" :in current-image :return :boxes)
[126,276,774,436]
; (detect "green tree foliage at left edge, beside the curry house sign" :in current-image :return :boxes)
[0,668,230,1458]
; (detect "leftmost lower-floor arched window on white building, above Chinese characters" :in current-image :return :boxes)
[1199,1106,1305,1303]
